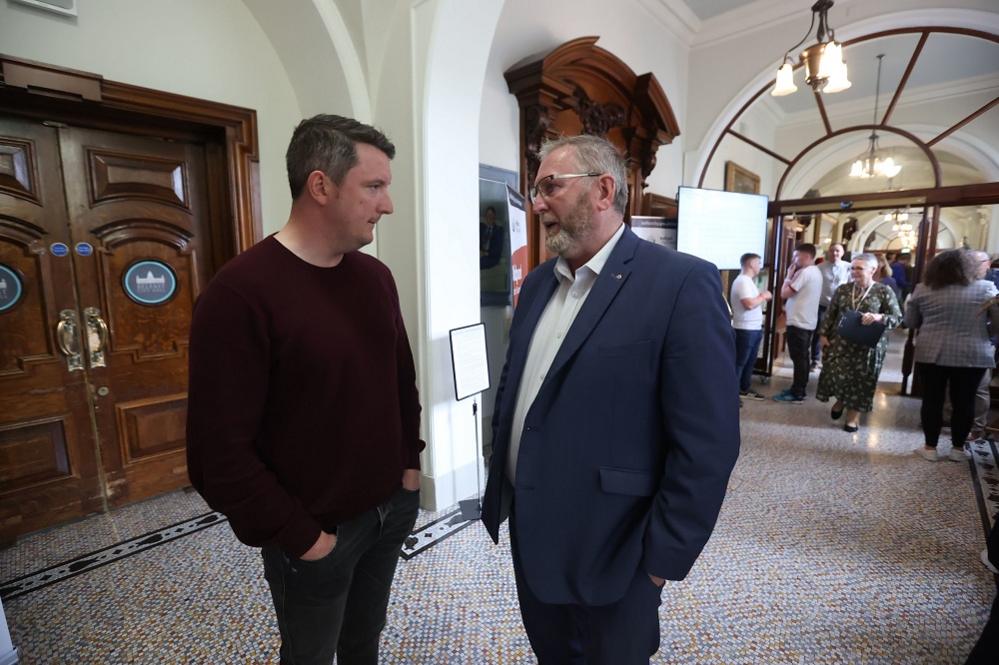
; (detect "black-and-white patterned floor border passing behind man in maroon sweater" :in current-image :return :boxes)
[0,498,477,602]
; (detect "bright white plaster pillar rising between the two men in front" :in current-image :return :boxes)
[413,0,504,506]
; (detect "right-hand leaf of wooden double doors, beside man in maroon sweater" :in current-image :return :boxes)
[60,128,211,505]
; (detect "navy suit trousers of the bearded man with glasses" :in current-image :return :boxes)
[510,510,662,665]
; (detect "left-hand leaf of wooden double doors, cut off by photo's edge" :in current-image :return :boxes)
[0,117,102,541]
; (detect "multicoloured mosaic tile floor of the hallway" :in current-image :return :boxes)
[0,334,996,665]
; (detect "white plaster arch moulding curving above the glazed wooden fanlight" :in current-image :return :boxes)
[690,9,999,189]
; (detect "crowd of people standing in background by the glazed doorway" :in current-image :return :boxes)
[729,243,999,446]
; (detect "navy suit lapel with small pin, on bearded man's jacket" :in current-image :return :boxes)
[538,227,640,395]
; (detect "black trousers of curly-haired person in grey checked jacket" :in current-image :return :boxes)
[916,363,985,448]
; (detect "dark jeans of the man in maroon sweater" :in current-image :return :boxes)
[261,488,420,665]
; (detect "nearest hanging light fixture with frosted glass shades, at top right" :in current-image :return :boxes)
[770,0,851,97]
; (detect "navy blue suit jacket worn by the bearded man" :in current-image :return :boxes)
[482,229,739,605]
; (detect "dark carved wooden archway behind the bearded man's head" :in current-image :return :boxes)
[505,37,680,268]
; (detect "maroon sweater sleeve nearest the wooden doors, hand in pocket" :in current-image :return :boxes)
[187,280,321,558]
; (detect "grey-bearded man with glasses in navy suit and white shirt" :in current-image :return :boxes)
[482,136,739,665]
